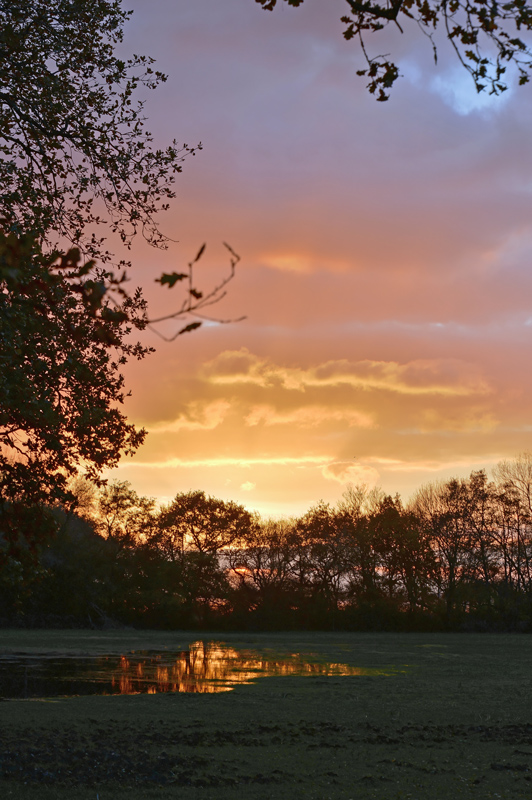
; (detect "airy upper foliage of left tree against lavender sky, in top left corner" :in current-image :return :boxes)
[0,0,197,261]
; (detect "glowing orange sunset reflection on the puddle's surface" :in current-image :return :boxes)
[108,641,397,694]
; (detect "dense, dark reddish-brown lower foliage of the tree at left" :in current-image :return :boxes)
[0,233,146,514]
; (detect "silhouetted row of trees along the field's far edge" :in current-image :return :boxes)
[0,454,532,630]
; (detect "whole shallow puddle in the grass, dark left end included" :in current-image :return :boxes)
[0,641,398,697]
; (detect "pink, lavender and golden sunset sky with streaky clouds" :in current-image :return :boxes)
[111,0,532,516]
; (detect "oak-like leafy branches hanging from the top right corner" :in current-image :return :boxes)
[255,0,532,101]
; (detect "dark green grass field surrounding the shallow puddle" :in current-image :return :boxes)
[0,631,532,800]
